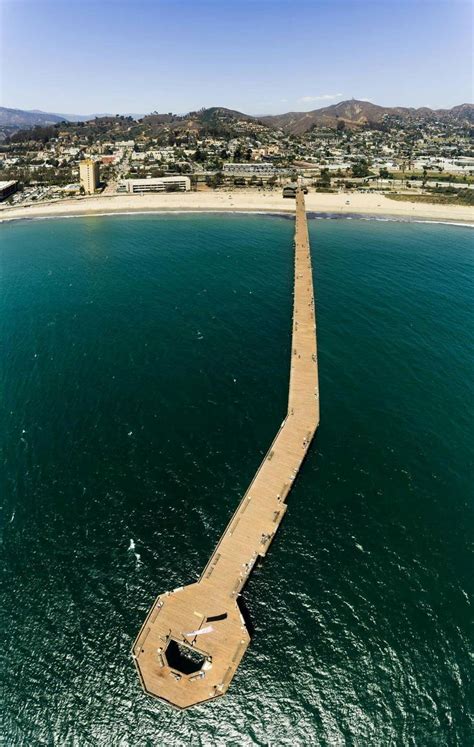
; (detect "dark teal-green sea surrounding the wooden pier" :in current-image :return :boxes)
[0,215,474,747]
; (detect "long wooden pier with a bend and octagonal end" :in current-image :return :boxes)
[132,189,319,708]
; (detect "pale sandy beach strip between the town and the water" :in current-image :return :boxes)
[0,189,474,224]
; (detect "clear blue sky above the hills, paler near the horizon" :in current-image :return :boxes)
[0,0,474,114]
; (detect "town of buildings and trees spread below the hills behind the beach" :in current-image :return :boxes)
[0,105,474,204]
